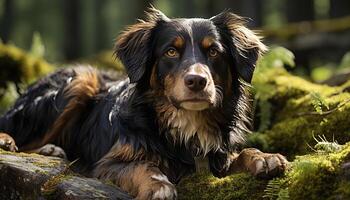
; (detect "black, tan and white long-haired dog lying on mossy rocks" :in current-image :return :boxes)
[0,8,288,199]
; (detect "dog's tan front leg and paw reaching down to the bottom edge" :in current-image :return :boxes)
[94,151,177,200]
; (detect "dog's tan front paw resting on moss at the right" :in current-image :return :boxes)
[239,148,288,178]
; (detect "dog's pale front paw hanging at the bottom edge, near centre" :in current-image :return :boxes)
[136,174,177,200]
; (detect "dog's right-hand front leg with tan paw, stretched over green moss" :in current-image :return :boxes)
[229,148,288,178]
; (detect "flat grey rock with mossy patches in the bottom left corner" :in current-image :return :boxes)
[0,149,132,200]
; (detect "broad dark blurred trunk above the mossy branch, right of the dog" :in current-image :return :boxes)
[286,0,315,22]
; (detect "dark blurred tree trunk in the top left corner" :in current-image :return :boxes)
[0,0,15,43]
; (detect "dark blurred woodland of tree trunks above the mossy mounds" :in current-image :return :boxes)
[0,0,350,74]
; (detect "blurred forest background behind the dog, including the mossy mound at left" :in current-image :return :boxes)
[0,0,350,111]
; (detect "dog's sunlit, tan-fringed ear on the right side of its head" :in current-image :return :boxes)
[210,11,267,83]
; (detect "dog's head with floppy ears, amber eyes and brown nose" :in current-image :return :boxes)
[115,8,266,110]
